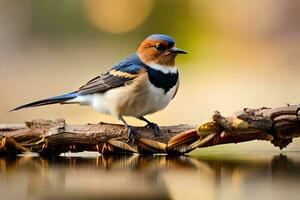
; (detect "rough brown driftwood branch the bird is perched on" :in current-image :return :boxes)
[0,105,300,155]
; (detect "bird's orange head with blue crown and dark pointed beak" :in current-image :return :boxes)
[137,34,187,67]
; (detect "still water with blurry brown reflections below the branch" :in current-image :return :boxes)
[0,153,300,200]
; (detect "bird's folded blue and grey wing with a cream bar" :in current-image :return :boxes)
[78,55,144,95]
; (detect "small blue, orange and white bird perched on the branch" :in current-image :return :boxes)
[13,34,186,141]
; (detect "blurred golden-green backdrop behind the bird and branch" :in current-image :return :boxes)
[0,0,300,151]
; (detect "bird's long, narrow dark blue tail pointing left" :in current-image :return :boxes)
[11,92,78,111]
